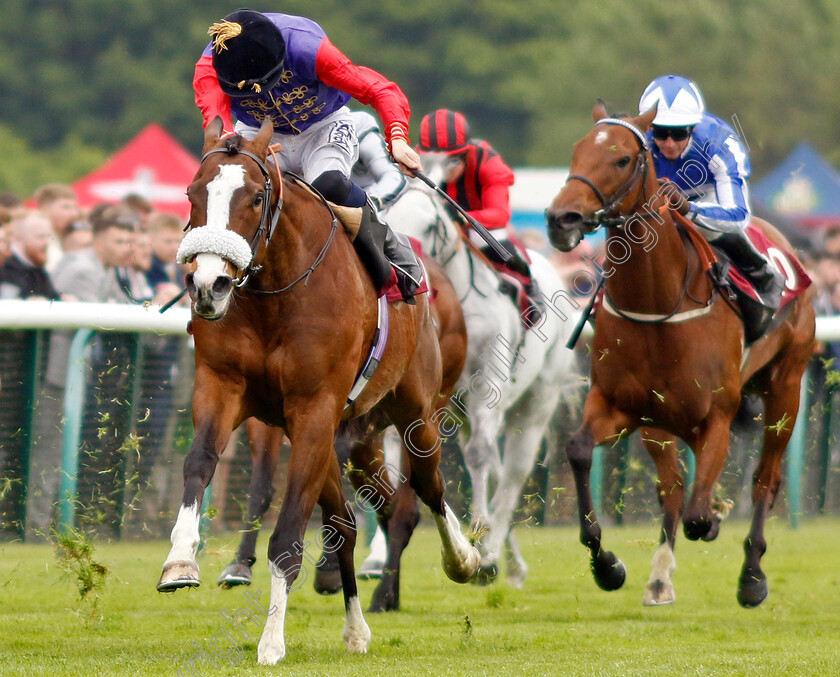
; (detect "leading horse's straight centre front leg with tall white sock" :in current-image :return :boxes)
[257,396,355,665]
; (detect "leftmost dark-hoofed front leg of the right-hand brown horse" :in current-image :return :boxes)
[566,385,636,590]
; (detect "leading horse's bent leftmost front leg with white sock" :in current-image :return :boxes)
[157,377,241,592]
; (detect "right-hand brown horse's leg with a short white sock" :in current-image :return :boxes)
[641,428,685,606]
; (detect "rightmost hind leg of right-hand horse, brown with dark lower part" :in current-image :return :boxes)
[738,363,807,608]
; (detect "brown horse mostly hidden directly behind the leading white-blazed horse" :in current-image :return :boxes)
[218,258,467,612]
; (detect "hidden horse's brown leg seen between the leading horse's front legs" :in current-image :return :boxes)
[217,418,283,588]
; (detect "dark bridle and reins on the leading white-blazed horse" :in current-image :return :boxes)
[192,146,338,295]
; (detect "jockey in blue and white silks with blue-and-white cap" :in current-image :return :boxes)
[639,75,783,307]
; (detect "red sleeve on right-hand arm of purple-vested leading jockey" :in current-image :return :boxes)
[315,38,411,147]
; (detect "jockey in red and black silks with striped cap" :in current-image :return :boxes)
[417,108,539,298]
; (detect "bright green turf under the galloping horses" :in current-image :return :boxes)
[0,518,840,677]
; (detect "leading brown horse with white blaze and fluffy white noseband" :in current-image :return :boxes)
[158,118,480,665]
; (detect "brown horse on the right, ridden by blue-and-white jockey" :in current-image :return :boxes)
[547,104,814,607]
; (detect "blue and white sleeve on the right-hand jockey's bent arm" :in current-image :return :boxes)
[689,136,750,233]
